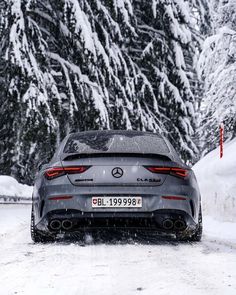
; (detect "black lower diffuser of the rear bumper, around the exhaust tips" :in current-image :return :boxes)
[36,209,197,236]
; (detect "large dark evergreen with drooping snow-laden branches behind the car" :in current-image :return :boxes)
[0,0,205,183]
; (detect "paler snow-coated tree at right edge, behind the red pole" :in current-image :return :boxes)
[198,0,236,154]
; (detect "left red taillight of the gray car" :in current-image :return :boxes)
[44,166,90,180]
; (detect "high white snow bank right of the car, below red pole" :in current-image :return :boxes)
[193,139,236,221]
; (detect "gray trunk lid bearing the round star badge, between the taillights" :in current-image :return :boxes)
[62,154,167,186]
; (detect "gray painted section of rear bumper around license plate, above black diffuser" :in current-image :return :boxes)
[34,192,199,222]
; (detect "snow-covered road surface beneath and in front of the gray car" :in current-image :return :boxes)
[0,205,236,295]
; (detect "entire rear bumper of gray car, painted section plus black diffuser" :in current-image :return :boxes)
[33,178,200,235]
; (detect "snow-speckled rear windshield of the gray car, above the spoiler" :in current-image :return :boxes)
[64,132,169,155]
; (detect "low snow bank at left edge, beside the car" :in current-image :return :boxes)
[0,175,33,198]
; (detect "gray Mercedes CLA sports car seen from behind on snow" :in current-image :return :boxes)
[31,131,202,242]
